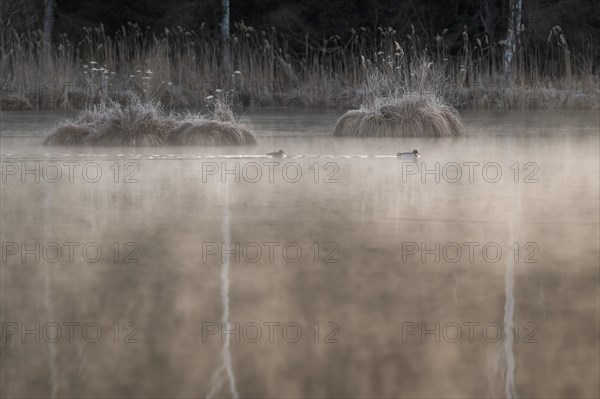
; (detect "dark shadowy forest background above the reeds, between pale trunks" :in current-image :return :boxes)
[2,0,600,54]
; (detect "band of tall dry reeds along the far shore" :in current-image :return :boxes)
[0,23,600,109]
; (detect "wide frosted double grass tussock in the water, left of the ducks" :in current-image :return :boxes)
[44,99,256,146]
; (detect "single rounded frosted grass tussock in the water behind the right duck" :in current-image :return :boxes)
[333,93,463,137]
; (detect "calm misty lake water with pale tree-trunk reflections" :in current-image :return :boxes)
[0,109,600,398]
